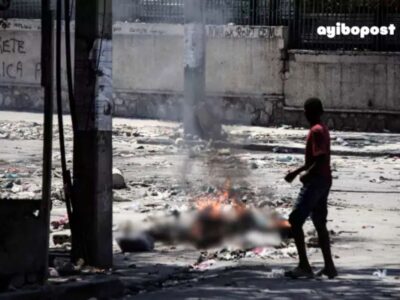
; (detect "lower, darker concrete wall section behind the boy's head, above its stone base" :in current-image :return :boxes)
[285,50,400,113]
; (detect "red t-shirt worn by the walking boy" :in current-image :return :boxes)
[306,123,332,180]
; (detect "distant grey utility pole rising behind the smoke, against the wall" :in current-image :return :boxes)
[183,0,206,136]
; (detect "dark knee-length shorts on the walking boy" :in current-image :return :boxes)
[290,177,332,225]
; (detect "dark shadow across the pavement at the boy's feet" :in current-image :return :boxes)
[127,266,400,299]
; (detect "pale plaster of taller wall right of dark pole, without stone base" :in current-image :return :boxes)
[113,23,286,95]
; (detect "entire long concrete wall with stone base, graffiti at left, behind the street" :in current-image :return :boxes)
[0,20,400,132]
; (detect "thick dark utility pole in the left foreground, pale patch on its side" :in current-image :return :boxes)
[72,0,113,268]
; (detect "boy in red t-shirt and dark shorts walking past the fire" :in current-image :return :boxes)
[285,98,337,279]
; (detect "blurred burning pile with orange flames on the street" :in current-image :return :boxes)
[118,179,290,251]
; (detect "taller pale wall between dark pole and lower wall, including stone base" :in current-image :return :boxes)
[113,23,287,125]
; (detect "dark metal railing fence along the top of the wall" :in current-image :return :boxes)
[0,0,400,51]
